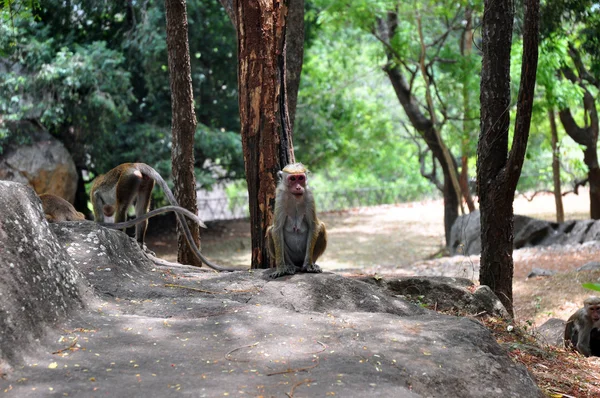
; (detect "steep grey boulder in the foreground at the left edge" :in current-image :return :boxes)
[0,181,86,370]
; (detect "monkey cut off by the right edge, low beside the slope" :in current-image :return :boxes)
[564,296,600,357]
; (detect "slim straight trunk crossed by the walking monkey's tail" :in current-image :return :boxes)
[165,0,202,267]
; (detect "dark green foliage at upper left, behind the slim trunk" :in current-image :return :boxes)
[0,0,244,184]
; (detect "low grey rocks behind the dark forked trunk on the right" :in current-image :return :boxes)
[449,210,600,255]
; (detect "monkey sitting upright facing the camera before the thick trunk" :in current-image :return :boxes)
[267,163,327,278]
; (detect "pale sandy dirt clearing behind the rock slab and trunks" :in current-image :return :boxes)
[149,190,600,324]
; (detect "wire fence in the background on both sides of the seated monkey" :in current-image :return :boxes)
[198,186,418,221]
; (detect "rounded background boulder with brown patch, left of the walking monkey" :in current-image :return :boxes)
[0,120,78,203]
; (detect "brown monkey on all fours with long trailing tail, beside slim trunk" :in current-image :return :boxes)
[90,163,235,271]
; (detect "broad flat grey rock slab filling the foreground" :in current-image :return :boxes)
[0,182,540,397]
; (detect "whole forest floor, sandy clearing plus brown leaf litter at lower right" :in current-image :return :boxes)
[147,190,600,397]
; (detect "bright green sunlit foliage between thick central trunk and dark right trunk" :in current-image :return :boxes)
[294,0,481,195]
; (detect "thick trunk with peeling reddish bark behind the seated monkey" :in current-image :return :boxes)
[233,0,294,268]
